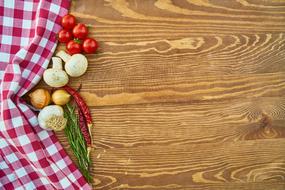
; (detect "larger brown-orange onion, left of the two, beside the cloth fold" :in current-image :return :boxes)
[29,88,51,109]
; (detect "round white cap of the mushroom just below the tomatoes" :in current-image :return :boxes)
[64,54,88,77]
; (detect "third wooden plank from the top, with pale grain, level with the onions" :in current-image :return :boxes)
[39,71,285,106]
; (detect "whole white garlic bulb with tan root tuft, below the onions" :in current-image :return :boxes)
[38,105,67,131]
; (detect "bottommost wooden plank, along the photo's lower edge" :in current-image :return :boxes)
[88,139,285,189]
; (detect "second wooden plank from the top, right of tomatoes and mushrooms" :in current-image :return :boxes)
[66,28,285,80]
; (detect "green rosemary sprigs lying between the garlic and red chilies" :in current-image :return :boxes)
[64,103,92,182]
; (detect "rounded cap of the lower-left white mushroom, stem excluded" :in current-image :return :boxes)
[44,68,68,88]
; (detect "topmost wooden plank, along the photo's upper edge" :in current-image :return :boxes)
[72,0,285,33]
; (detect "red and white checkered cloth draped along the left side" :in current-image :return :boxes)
[0,0,91,190]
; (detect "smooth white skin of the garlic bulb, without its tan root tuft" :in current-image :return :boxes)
[38,105,63,130]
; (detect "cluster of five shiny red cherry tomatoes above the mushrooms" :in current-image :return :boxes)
[58,14,98,55]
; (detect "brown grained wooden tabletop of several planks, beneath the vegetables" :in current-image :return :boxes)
[52,0,285,190]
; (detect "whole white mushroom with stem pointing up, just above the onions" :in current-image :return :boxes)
[44,57,68,87]
